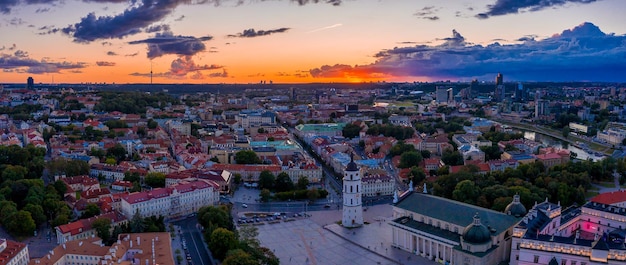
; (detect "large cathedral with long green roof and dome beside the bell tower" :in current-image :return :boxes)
[390,191,519,265]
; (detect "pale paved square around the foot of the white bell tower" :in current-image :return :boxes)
[251,205,437,265]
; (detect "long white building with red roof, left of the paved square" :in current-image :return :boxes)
[121,179,220,219]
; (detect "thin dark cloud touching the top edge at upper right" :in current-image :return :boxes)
[476,0,598,19]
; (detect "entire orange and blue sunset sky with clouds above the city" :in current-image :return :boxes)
[0,0,626,84]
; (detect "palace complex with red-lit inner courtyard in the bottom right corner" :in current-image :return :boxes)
[510,200,626,265]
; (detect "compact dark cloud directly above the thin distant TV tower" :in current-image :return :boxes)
[129,32,213,59]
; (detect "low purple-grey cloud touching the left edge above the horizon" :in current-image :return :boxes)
[0,50,87,74]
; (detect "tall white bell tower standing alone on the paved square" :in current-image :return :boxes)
[341,154,363,227]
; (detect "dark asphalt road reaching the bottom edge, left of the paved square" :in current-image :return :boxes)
[174,218,216,265]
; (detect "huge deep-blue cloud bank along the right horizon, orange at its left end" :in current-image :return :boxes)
[309,23,626,82]
